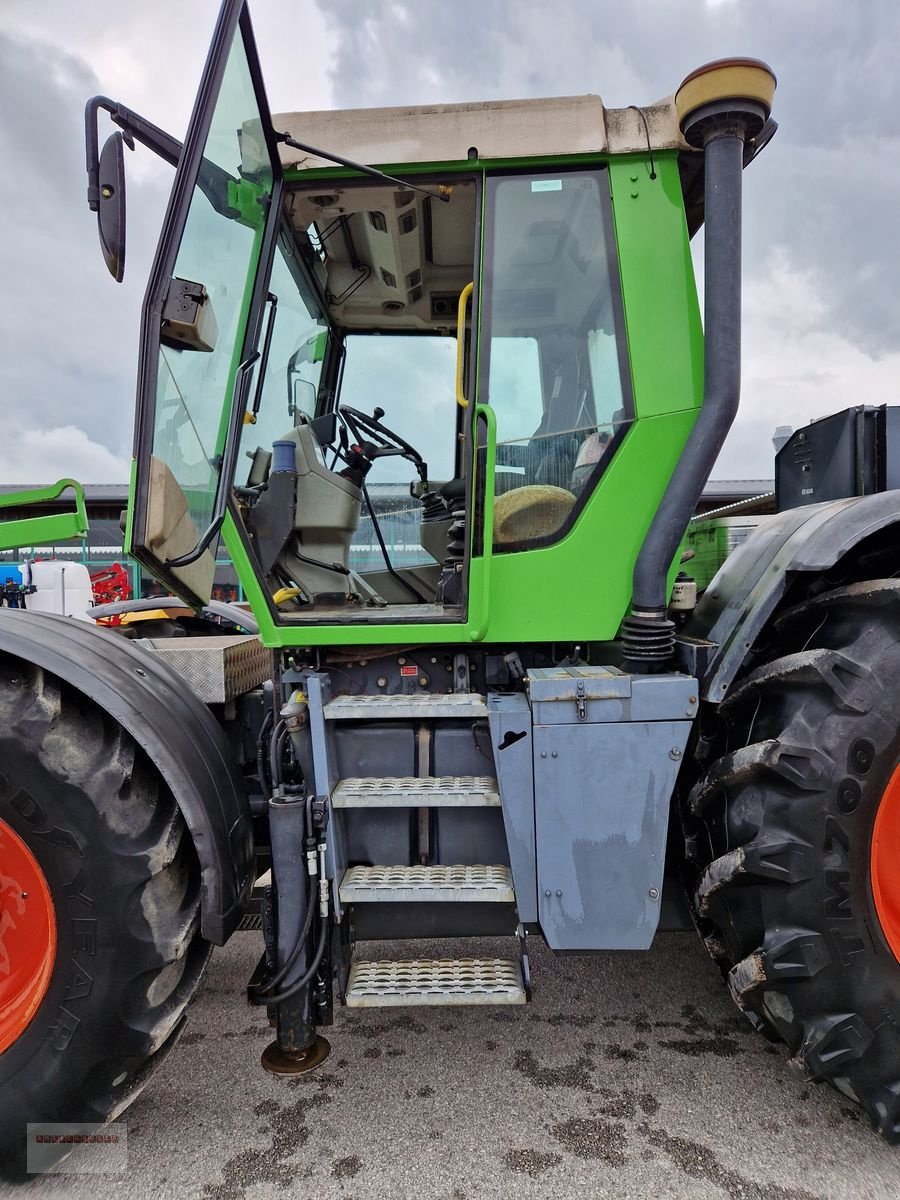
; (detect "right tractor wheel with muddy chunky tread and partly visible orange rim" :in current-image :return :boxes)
[683,580,900,1142]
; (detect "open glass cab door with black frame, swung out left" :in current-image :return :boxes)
[130,0,281,605]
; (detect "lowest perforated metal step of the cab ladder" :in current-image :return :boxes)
[346,959,527,1008]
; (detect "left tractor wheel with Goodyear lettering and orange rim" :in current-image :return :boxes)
[0,658,211,1177]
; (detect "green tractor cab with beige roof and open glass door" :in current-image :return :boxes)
[89,4,702,646]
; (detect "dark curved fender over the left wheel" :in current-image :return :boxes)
[0,608,253,946]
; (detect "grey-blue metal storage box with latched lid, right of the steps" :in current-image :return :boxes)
[528,666,697,950]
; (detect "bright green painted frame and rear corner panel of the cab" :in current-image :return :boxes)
[213,154,703,648]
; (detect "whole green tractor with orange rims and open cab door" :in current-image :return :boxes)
[0,0,900,1158]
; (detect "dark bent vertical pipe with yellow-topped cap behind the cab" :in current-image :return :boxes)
[622,59,775,673]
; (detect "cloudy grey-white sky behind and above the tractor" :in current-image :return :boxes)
[0,0,900,482]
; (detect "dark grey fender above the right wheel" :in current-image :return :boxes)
[685,491,900,703]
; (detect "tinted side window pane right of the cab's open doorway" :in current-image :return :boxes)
[481,169,632,551]
